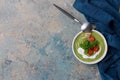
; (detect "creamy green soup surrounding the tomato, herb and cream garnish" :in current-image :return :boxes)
[73,30,107,62]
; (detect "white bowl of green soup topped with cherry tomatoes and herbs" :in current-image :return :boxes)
[72,30,108,64]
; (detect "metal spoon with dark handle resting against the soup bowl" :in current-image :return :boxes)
[53,4,94,32]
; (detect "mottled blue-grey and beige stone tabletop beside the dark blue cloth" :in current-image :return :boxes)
[0,0,101,80]
